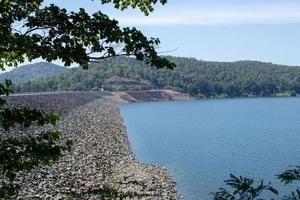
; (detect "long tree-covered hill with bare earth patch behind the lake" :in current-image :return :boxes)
[10,57,300,97]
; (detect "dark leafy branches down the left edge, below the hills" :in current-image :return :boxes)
[0,80,72,198]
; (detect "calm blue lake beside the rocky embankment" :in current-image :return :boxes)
[121,97,300,200]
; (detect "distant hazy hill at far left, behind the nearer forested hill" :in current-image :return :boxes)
[0,62,67,83]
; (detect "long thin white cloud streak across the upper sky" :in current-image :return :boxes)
[116,3,300,26]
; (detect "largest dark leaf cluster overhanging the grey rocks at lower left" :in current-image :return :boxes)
[0,131,72,184]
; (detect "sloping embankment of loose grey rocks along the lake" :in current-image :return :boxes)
[1,92,177,199]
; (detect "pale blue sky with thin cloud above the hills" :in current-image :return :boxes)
[46,0,300,66]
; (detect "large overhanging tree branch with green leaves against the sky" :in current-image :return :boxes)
[0,0,175,69]
